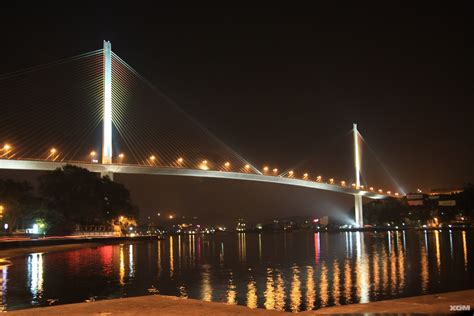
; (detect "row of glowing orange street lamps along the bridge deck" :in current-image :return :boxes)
[3,144,399,197]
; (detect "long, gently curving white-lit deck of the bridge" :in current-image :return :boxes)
[0,159,388,199]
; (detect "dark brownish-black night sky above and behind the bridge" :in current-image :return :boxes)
[0,1,474,225]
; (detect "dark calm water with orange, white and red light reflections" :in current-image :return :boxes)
[0,231,474,311]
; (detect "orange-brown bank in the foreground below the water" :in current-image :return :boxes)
[10,290,474,316]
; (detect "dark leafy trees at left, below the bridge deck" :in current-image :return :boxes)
[0,165,138,235]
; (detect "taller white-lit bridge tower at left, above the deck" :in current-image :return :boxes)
[102,41,112,164]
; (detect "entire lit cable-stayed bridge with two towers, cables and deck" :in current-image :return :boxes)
[0,42,399,227]
